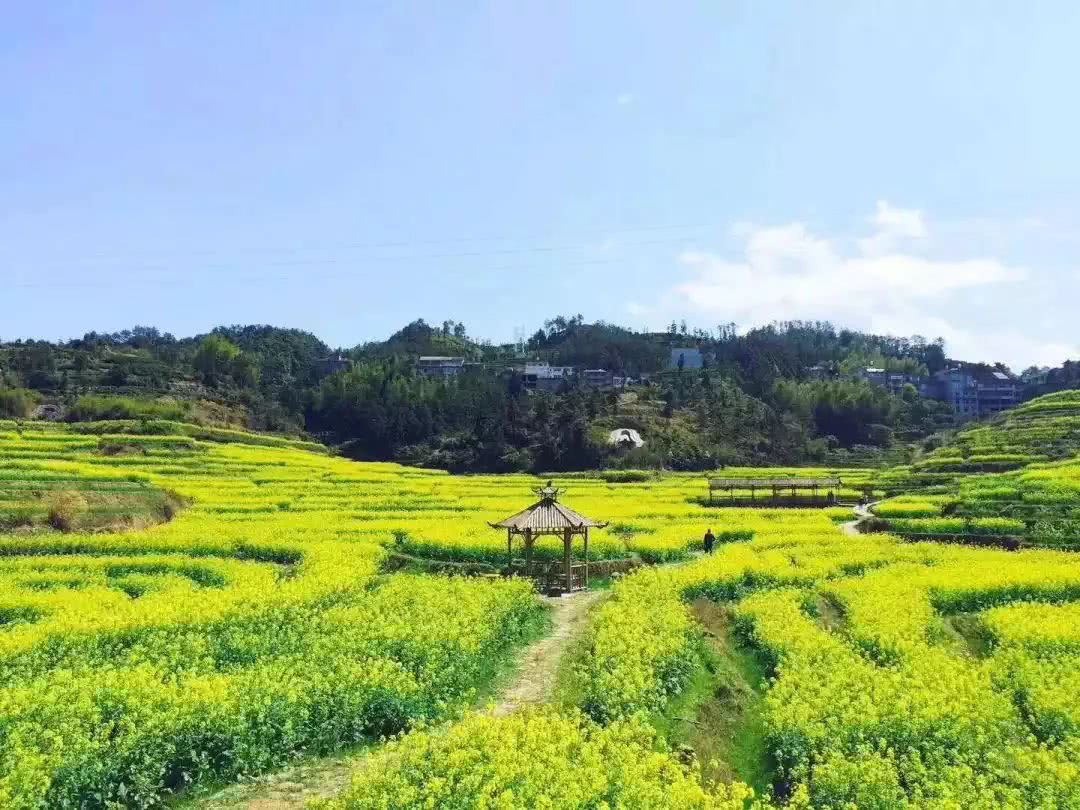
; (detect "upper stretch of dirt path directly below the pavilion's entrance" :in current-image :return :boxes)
[491,591,605,717]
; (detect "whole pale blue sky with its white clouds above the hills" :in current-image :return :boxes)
[0,0,1080,368]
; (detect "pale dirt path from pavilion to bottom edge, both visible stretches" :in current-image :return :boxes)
[184,591,606,810]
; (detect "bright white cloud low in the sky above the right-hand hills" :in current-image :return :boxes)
[664,201,1080,365]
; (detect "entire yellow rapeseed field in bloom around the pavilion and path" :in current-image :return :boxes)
[0,426,1080,810]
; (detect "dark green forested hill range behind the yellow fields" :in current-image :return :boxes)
[0,315,1080,471]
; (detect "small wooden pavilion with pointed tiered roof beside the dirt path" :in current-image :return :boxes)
[488,481,607,593]
